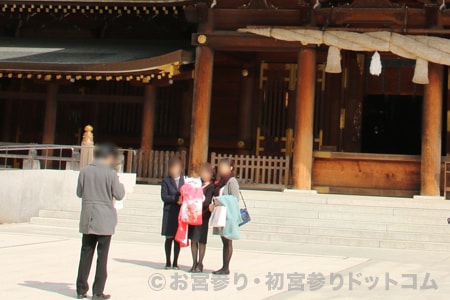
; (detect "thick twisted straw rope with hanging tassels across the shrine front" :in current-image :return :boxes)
[238,27,450,84]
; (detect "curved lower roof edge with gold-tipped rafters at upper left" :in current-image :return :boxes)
[0,41,194,81]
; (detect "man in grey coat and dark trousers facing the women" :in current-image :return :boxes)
[77,144,125,300]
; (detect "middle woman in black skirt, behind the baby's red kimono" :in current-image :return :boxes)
[189,163,215,273]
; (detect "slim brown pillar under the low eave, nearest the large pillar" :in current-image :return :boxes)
[141,85,157,151]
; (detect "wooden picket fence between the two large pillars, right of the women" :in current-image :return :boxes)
[211,152,290,190]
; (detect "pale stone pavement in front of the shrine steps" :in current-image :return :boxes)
[0,224,450,300]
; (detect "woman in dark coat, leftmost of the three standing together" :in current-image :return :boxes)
[161,157,184,270]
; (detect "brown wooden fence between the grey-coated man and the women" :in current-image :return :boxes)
[130,150,186,183]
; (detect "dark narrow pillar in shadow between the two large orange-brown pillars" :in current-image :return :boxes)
[237,69,255,154]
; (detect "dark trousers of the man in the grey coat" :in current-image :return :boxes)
[77,234,111,295]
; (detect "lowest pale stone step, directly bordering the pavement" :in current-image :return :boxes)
[31,217,450,251]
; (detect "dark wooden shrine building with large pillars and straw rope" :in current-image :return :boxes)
[0,0,450,197]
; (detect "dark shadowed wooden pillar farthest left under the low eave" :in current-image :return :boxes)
[42,82,58,144]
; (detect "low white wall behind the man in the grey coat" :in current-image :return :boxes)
[0,170,136,223]
